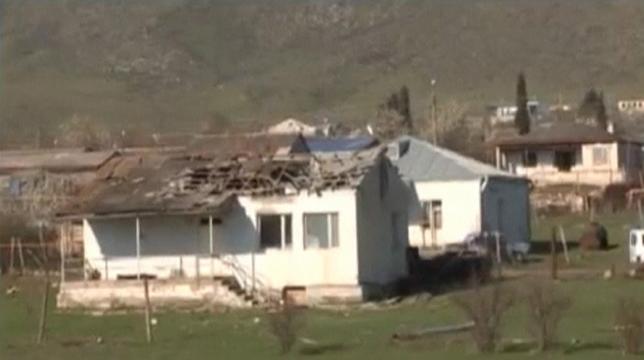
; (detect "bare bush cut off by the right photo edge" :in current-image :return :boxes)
[615,299,644,354]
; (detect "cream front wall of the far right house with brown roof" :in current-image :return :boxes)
[502,142,641,186]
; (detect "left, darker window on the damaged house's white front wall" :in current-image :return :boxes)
[257,214,293,249]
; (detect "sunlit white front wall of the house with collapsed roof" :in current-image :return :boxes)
[84,190,358,288]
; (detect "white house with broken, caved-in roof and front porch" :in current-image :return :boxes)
[58,145,408,306]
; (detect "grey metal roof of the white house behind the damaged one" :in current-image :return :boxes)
[388,136,520,181]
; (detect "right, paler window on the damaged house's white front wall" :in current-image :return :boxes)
[304,213,339,249]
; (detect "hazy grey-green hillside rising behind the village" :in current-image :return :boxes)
[0,0,644,146]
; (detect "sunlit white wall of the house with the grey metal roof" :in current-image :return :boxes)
[409,179,481,247]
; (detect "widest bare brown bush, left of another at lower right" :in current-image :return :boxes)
[452,278,514,352]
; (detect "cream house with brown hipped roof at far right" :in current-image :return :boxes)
[491,123,642,186]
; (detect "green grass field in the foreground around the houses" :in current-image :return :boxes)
[0,214,644,359]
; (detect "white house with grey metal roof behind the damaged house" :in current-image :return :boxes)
[388,136,530,252]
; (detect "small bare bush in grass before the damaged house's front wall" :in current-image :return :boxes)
[268,302,303,354]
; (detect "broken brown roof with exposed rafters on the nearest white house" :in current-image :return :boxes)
[58,149,382,218]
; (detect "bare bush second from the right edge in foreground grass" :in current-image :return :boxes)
[526,281,572,351]
